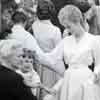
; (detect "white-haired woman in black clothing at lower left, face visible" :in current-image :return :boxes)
[0,39,55,100]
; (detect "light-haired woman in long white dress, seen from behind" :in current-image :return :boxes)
[34,5,100,100]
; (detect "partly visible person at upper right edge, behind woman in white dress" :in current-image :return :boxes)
[85,0,100,35]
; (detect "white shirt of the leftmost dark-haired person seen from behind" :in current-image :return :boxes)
[8,25,39,51]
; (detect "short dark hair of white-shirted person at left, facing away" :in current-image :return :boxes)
[12,11,27,24]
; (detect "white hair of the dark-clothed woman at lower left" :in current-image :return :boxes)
[0,39,22,59]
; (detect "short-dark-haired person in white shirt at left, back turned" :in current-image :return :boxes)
[6,11,38,51]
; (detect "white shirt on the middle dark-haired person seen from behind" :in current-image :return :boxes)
[32,20,61,52]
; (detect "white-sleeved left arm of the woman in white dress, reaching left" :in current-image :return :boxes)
[37,41,65,74]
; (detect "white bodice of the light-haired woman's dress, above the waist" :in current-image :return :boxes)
[64,33,93,66]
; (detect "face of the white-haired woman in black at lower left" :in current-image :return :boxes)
[11,49,33,72]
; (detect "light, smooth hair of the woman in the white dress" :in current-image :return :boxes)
[58,5,83,27]
